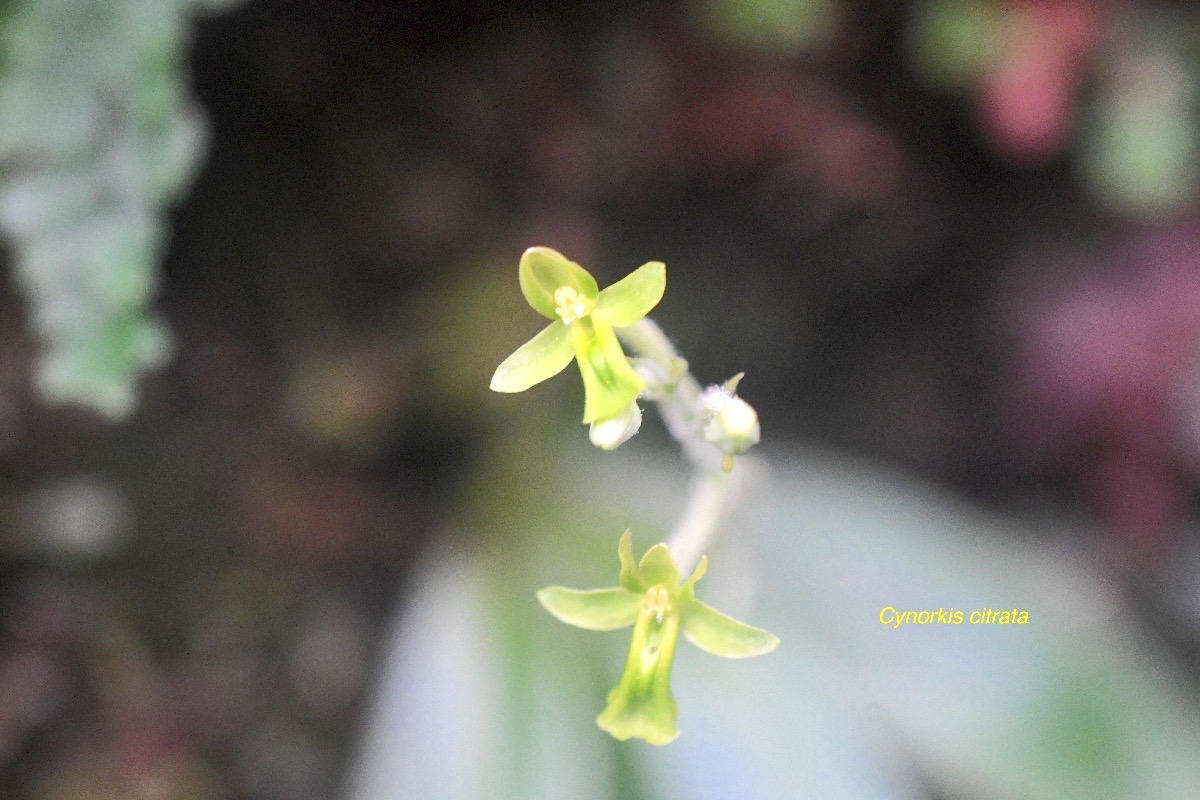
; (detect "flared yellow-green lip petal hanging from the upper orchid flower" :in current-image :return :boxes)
[570,314,646,423]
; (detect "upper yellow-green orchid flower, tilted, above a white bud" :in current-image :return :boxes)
[491,247,667,423]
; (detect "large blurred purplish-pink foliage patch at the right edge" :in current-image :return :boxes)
[1007,225,1200,566]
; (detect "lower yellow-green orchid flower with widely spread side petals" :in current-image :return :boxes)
[538,530,779,745]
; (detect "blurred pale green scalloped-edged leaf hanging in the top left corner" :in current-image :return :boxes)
[0,0,241,419]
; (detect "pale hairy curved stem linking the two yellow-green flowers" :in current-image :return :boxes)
[617,319,742,575]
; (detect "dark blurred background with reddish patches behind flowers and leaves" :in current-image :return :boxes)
[0,0,1200,800]
